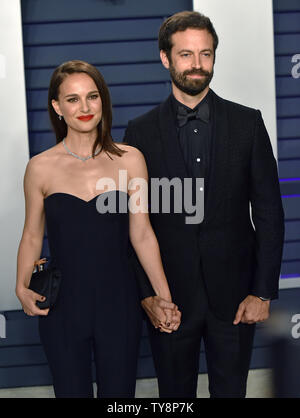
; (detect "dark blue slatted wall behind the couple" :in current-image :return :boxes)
[0,0,300,387]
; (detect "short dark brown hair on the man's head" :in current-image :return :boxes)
[158,11,219,61]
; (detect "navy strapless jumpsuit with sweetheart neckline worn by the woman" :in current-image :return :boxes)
[39,190,142,397]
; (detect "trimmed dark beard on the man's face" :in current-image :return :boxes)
[169,63,214,96]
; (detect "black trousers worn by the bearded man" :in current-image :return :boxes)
[147,279,255,398]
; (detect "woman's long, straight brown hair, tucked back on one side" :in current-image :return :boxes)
[48,60,126,157]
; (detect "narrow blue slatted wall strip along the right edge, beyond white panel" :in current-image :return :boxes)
[274,0,300,278]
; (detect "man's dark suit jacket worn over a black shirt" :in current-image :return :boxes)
[124,92,284,320]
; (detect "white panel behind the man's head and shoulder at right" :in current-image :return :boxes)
[194,0,277,158]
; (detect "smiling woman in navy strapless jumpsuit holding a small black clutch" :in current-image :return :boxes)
[16,61,179,397]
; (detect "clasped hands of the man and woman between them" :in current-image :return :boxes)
[141,296,181,333]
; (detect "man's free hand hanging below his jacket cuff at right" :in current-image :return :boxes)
[233,295,270,325]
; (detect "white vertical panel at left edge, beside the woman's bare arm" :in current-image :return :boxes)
[0,0,29,311]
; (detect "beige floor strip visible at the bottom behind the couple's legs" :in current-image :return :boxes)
[0,369,272,398]
